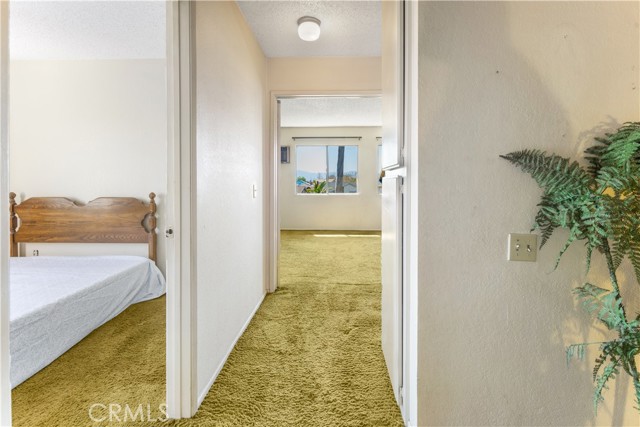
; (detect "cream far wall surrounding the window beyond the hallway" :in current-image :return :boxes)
[278,127,382,230]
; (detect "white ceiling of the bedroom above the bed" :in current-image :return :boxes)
[9,0,166,59]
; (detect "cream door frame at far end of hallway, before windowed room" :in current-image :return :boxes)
[266,90,382,293]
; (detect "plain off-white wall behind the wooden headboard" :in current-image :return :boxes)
[10,59,167,270]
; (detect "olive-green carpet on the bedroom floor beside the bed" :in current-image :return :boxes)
[11,296,166,427]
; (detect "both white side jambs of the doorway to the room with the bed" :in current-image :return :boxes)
[0,0,197,426]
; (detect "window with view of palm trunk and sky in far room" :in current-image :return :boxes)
[296,145,358,194]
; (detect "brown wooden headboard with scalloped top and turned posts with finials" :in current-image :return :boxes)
[9,193,157,262]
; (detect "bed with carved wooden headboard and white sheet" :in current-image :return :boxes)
[9,193,165,388]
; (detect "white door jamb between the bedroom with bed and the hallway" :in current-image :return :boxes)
[165,0,198,418]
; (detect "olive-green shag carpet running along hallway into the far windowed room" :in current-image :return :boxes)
[175,231,403,426]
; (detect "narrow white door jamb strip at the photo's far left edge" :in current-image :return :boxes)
[0,1,11,426]
